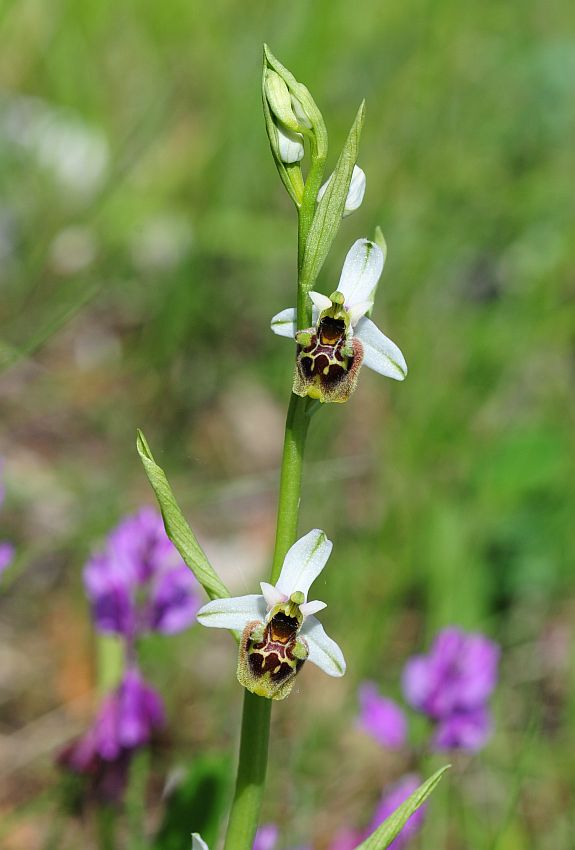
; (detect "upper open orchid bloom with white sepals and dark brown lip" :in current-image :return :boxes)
[271,234,407,402]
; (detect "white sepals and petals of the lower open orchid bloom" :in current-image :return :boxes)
[197,528,346,676]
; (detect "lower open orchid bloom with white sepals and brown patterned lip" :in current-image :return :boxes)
[197,528,345,699]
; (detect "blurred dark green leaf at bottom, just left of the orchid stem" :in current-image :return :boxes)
[152,755,233,850]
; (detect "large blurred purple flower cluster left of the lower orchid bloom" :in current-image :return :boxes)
[84,508,200,639]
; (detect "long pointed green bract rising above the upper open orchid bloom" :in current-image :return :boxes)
[301,101,365,291]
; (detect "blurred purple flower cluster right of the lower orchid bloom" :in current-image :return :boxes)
[403,627,500,751]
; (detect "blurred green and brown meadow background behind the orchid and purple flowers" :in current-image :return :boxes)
[0,0,575,850]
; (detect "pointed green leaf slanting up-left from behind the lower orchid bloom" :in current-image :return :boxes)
[136,430,230,599]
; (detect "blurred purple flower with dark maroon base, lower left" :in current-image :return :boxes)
[58,667,165,801]
